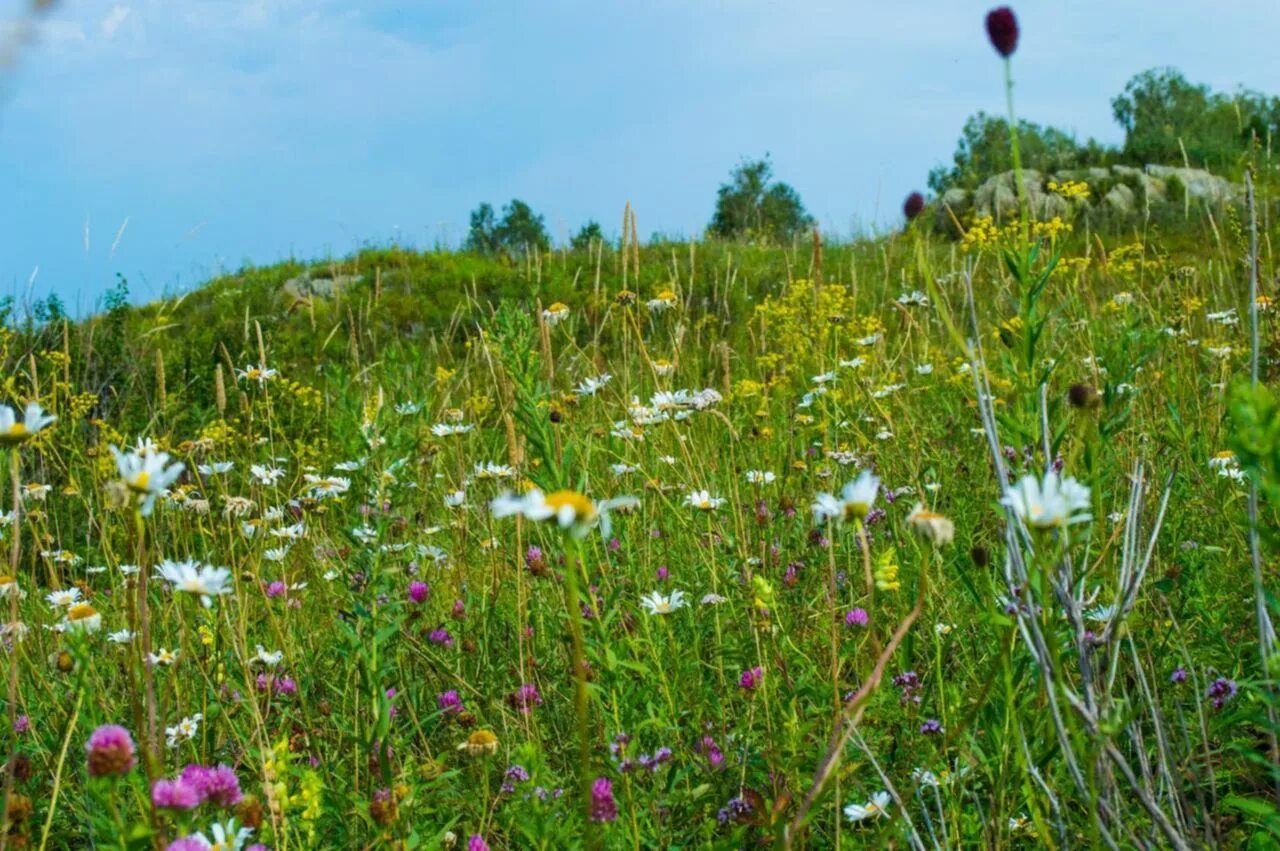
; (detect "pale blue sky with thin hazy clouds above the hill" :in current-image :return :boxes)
[0,0,1280,315]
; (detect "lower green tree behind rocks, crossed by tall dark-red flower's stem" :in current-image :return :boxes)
[929,113,1115,195]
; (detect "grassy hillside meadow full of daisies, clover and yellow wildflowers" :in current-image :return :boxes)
[0,8,1280,851]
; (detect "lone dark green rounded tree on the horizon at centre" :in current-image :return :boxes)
[707,156,813,241]
